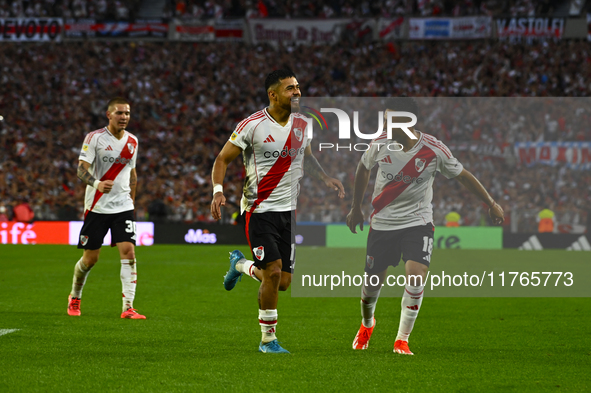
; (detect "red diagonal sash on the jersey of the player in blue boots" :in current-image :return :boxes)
[250,119,307,213]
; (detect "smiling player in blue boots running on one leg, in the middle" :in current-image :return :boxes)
[211,70,345,353]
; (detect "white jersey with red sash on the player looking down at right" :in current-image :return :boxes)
[361,132,464,231]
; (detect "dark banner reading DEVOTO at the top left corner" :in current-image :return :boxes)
[0,18,63,42]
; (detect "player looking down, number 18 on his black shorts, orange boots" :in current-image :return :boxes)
[347,98,504,355]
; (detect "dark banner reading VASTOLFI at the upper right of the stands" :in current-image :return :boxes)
[495,16,565,38]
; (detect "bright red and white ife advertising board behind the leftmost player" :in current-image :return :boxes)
[0,221,154,246]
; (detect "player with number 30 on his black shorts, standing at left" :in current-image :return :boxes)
[68,97,146,319]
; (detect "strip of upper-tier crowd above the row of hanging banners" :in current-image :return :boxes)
[0,0,560,20]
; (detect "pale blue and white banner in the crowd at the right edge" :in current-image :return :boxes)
[515,142,591,170]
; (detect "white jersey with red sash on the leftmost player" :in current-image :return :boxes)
[79,127,138,216]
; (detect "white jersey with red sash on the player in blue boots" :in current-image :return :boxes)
[230,109,311,213]
